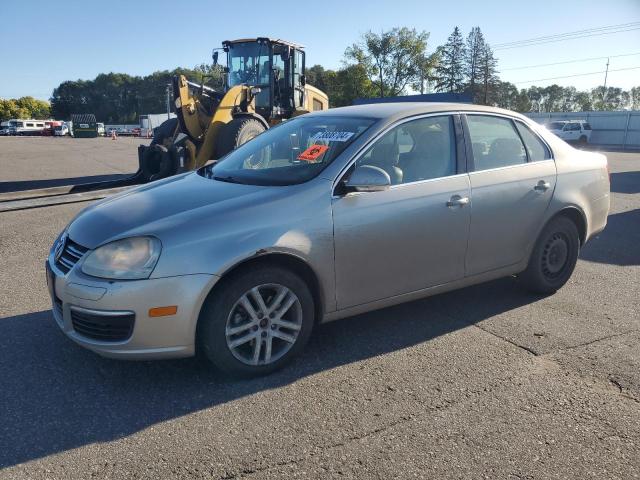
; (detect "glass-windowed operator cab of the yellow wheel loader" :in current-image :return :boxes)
[222,38,305,121]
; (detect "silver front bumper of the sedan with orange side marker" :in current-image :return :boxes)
[46,255,218,360]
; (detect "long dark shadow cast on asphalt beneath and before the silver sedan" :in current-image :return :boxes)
[0,278,539,468]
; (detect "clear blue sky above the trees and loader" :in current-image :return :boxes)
[0,0,640,99]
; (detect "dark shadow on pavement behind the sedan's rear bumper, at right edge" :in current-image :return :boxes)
[580,209,640,265]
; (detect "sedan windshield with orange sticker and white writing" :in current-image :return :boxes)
[200,116,374,185]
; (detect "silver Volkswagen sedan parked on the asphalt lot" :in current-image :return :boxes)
[46,103,609,375]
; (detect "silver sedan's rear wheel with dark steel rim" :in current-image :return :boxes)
[519,216,580,295]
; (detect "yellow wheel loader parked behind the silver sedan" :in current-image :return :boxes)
[138,37,329,183]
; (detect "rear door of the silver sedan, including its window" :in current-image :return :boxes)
[464,113,556,276]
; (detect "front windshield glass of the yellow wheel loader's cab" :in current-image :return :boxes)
[227,42,269,87]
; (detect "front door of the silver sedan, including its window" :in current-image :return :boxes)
[333,115,470,309]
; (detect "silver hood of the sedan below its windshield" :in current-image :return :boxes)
[68,172,276,249]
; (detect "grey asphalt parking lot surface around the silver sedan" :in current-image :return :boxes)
[0,138,640,479]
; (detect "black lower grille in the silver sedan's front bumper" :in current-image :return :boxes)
[71,308,136,342]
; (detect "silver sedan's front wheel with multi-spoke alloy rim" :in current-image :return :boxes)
[196,265,314,377]
